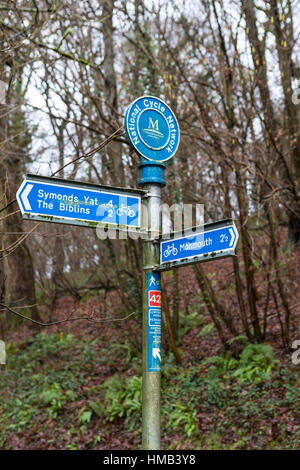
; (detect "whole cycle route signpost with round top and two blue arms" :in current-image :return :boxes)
[17,96,238,450]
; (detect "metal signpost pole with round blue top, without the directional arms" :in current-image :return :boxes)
[124,96,180,450]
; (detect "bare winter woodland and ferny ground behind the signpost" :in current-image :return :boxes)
[0,0,300,448]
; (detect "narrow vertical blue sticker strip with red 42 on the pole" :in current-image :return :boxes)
[147,272,161,372]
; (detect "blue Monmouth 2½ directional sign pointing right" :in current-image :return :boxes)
[160,221,238,267]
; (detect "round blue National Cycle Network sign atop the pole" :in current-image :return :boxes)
[124,96,180,162]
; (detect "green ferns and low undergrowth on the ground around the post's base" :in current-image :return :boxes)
[0,328,300,449]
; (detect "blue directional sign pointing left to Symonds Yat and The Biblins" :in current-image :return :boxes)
[17,175,144,229]
